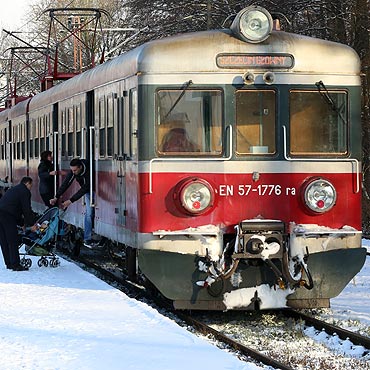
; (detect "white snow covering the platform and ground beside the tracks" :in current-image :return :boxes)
[0,243,370,370]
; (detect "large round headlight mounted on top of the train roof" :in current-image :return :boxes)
[230,5,273,43]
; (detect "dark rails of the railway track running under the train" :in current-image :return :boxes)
[57,246,370,370]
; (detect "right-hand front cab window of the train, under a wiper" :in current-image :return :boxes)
[289,91,348,155]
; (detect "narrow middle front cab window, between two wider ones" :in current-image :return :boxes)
[235,90,276,155]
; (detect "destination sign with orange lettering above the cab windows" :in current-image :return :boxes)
[216,54,294,69]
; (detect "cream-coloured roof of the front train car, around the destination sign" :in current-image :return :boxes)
[30,29,360,110]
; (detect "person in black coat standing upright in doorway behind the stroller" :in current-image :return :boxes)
[38,150,58,208]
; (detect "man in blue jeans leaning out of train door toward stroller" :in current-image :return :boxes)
[50,158,95,248]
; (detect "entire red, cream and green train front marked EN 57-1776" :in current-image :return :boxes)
[137,7,366,310]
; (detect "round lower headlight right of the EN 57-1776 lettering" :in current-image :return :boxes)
[304,179,337,213]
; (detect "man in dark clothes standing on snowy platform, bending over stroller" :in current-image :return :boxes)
[0,177,37,271]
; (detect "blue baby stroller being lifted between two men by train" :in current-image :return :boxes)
[19,207,63,268]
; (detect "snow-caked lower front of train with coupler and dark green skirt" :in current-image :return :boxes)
[138,220,366,310]
